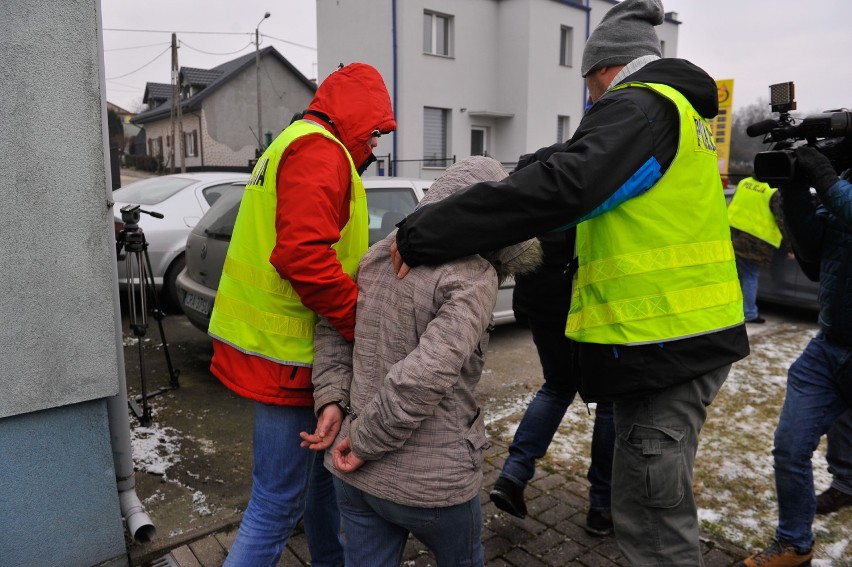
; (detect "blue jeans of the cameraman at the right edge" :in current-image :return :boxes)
[772,331,852,549]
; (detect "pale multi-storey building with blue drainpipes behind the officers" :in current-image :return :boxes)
[317,0,679,178]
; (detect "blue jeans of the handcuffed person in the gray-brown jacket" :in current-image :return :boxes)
[334,477,485,567]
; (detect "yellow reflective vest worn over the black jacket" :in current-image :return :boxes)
[565,83,743,345]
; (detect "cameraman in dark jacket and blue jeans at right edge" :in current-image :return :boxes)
[738,146,852,567]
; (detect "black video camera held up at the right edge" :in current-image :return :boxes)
[746,81,852,187]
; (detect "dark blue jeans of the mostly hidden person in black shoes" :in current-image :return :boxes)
[500,316,615,511]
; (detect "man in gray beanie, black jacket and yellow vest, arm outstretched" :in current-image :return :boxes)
[391,0,749,565]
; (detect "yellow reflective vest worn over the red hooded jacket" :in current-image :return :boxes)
[209,120,369,366]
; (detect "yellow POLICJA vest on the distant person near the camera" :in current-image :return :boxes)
[728,177,782,248]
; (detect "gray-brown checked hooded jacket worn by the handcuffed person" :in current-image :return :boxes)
[313,158,541,508]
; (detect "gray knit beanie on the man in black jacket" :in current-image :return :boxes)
[580,0,665,77]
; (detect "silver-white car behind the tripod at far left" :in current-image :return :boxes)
[112,172,249,308]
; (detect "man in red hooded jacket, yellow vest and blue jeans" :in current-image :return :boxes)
[209,63,396,567]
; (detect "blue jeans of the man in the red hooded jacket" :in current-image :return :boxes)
[230,403,343,567]
